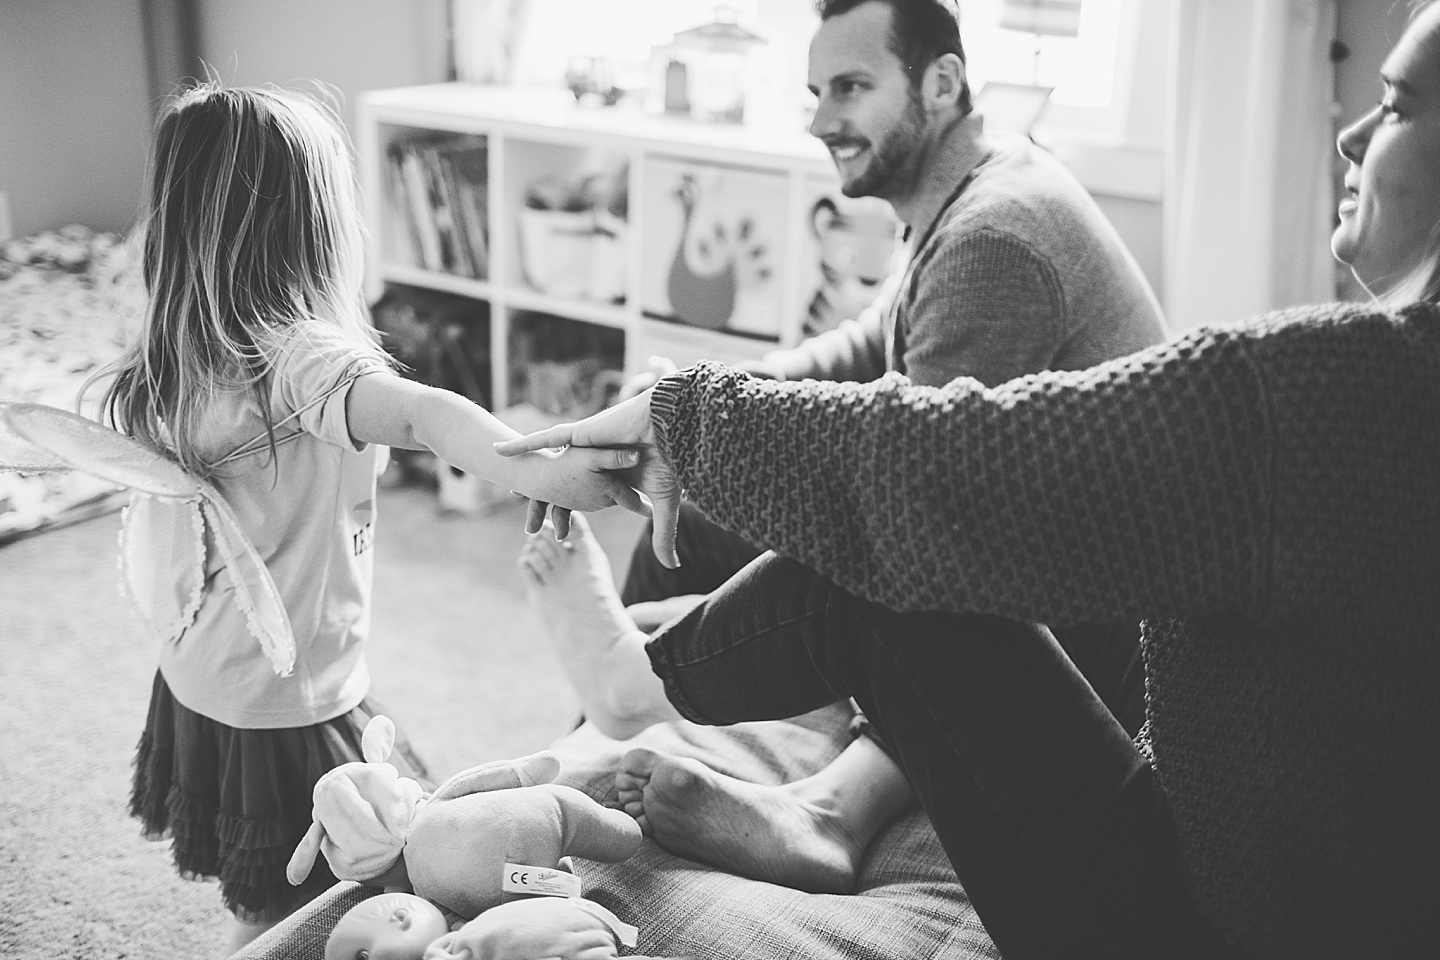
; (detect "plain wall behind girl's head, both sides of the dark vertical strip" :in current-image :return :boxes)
[0,0,449,236]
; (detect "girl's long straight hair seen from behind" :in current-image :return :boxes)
[86,82,383,475]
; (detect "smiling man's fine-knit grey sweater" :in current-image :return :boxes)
[765,127,1165,386]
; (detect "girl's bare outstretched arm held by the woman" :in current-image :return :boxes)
[346,373,644,512]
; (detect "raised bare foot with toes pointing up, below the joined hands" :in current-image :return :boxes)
[520,514,680,740]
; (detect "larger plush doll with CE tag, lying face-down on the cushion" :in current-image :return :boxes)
[288,717,641,920]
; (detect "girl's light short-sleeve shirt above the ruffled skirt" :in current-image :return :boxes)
[160,321,393,728]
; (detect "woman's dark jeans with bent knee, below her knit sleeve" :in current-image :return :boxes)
[648,554,1224,960]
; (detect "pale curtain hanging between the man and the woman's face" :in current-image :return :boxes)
[1164,0,1336,332]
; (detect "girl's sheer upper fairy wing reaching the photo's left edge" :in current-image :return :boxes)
[0,403,200,499]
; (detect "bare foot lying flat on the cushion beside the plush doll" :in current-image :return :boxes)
[615,747,870,894]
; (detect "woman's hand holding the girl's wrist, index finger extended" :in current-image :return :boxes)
[495,390,680,569]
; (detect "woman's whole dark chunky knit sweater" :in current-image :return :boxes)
[651,305,1440,957]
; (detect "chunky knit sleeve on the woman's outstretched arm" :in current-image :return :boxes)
[651,331,1272,623]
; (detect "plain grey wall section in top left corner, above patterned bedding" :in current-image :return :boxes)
[0,0,150,236]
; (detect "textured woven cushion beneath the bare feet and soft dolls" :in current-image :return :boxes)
[232,705,999,960]
